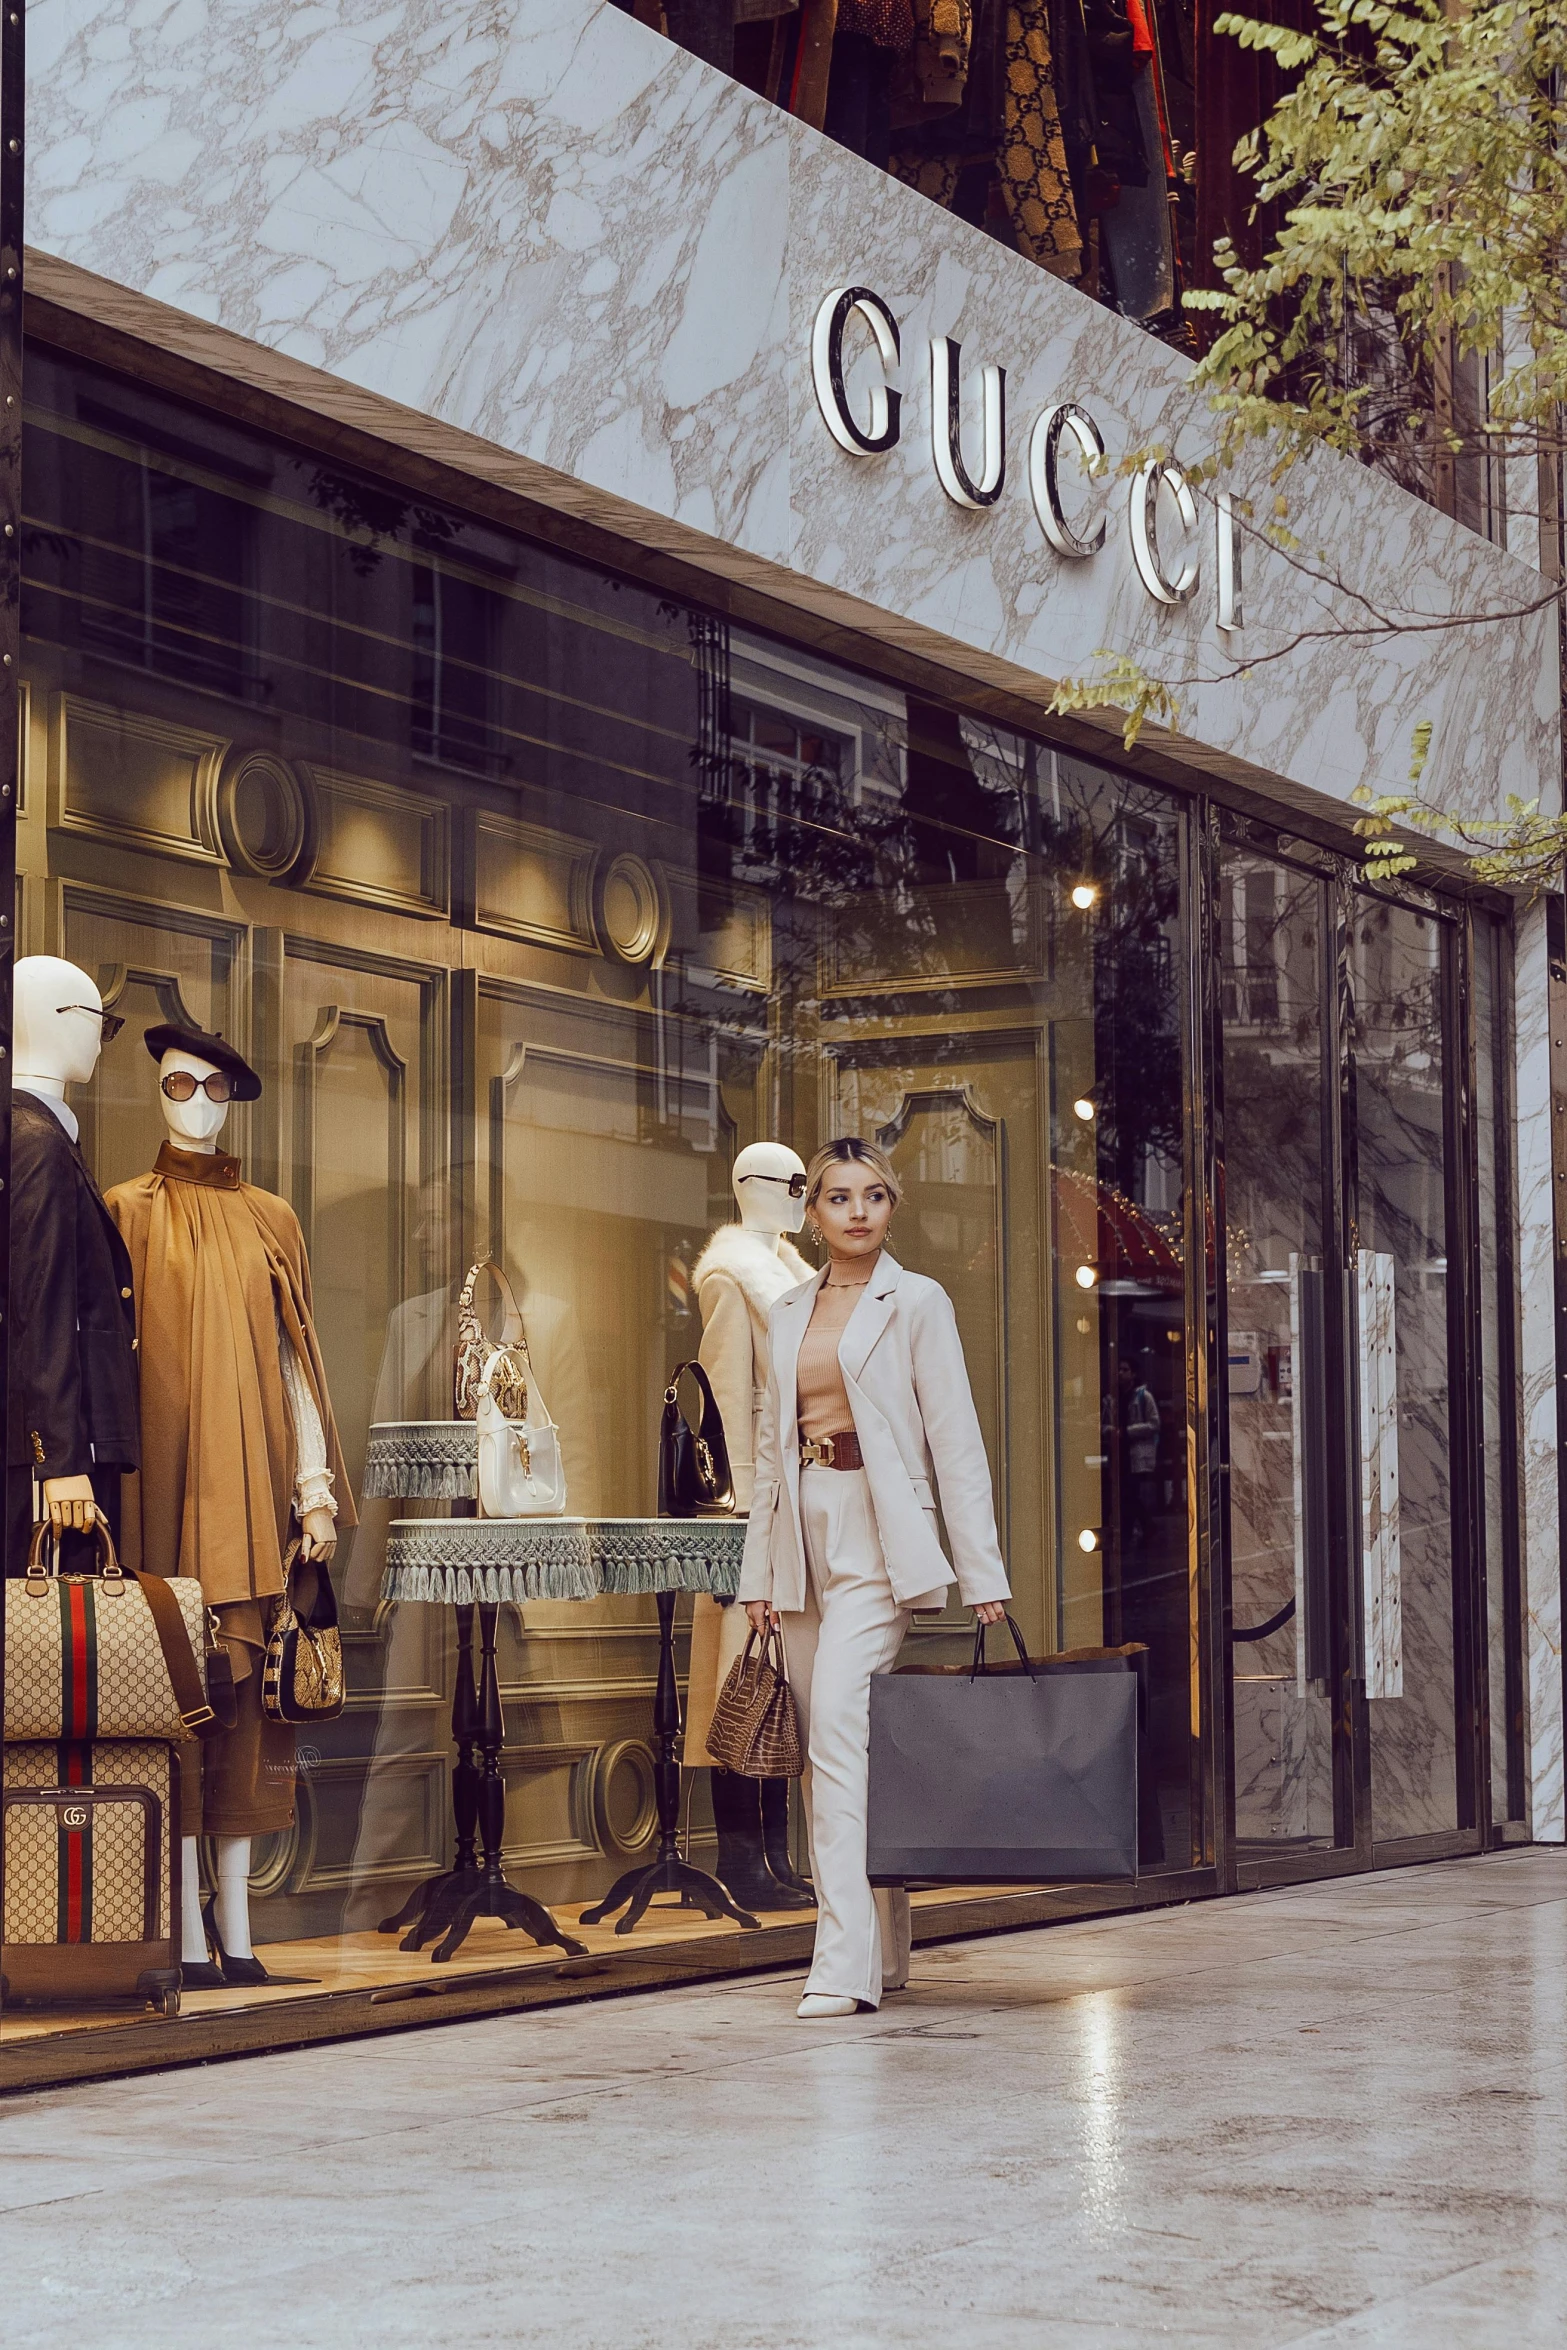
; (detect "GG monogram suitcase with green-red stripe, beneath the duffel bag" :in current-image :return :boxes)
[0,1739,179,2016]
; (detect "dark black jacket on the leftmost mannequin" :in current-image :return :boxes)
[5,1093,141,1478]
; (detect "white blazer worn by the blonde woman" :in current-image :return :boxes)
[740,1248,1010,1612]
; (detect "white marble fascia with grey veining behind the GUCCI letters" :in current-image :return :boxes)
[18,0,1555,827]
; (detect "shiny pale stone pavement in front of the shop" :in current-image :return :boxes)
[0,1847,1567,2350]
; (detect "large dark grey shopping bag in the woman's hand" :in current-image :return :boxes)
[867,1617,1137,1885]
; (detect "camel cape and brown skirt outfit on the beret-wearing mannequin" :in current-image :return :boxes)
[108,1142,355,1835]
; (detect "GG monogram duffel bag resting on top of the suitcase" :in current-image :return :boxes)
[5,1518,223,1744]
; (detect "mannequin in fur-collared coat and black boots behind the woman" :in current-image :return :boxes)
[686,1142,813,1908]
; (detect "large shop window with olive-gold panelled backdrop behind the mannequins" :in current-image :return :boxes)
[5,350,1212,2035]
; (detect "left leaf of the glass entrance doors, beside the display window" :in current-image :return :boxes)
[1219,846,1353,1868]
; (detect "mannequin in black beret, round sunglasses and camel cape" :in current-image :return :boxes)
[108,1027,355,1988]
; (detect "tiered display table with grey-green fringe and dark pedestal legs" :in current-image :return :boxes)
[364,1419,756,1962]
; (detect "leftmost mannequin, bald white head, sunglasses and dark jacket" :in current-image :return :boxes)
[5,954,139,1575]
